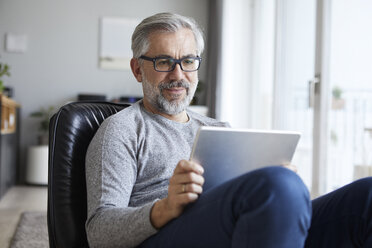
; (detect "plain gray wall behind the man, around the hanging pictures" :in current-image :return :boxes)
[0,0,208,182]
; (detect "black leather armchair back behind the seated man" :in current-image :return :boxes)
[48,102,129,248]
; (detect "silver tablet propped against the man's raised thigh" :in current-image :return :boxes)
[190,127,301,191]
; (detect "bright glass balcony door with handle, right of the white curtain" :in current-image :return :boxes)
[273,0,372,197]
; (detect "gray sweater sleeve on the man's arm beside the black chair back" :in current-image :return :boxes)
[86,118,156,247]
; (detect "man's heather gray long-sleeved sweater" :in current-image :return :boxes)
[86,101,227,247]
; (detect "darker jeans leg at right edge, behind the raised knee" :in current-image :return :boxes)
[305,177,372,248]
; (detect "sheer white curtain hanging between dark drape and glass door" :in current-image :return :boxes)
[215,0,275,128]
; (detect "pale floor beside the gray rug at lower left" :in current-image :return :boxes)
[0,186,47,248]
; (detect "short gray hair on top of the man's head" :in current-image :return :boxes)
[132,13,204,58]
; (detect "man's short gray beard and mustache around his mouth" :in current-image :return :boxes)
[142,73,196,115]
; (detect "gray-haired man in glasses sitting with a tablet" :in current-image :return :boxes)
[86,13,372,248]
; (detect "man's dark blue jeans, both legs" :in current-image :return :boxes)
[139,166,372,248]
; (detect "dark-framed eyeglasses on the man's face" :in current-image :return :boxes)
[139,56,201,72]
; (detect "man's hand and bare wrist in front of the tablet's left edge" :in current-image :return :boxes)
[150,160,204,228]
